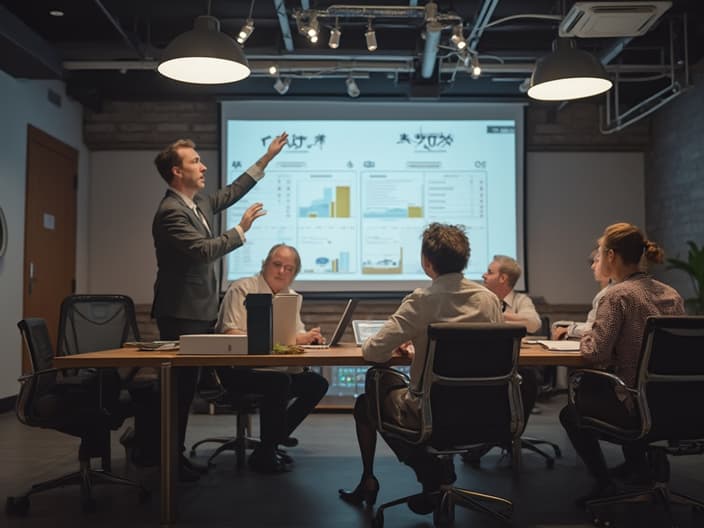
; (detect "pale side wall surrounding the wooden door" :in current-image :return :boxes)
[0,71,88,398]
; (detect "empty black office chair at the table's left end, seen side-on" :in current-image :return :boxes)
[5,318,149,515]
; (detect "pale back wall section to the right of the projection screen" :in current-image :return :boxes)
[526,152,645,303]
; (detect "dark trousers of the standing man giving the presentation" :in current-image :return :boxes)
[156,317,215,451]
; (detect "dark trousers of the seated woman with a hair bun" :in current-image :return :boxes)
[560,384,646,483]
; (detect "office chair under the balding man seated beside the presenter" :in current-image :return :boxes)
[190,368,261,469]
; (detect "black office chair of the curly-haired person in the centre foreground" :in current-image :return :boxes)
[369,323,525,528]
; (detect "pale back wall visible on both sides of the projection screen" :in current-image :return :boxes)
[88,151,645,304]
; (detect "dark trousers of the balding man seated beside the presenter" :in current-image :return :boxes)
[217,367,328,449]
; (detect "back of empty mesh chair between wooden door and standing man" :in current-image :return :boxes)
[56,295,140,356]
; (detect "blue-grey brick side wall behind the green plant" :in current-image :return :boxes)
[645,63,704,297]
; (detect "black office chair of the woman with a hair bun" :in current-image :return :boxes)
[569,316,704,526]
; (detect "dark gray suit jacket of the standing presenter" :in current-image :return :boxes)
[152,172,256,321]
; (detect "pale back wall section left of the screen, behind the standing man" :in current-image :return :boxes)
[87,151,219,304]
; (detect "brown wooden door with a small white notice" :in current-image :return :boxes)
[22,126,78,372]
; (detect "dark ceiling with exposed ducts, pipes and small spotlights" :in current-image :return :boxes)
[0,0,704,120]
